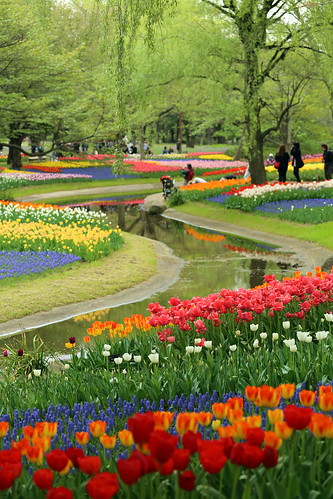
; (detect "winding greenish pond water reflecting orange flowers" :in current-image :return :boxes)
[1,205,299,351]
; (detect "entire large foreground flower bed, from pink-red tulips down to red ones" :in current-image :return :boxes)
[0,268,333,499]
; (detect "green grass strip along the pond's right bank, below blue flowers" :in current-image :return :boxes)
[177,203,333,250]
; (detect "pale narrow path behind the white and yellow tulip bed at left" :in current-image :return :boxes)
[15,182,162,203]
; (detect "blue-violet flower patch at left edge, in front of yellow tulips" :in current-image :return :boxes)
[0,251,81,280]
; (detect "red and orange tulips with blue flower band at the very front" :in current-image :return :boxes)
[0,384,333,499]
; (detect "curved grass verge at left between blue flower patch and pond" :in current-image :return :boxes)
[0,233,157,323]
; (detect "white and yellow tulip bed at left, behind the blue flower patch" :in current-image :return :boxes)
[0,201,123,268]
